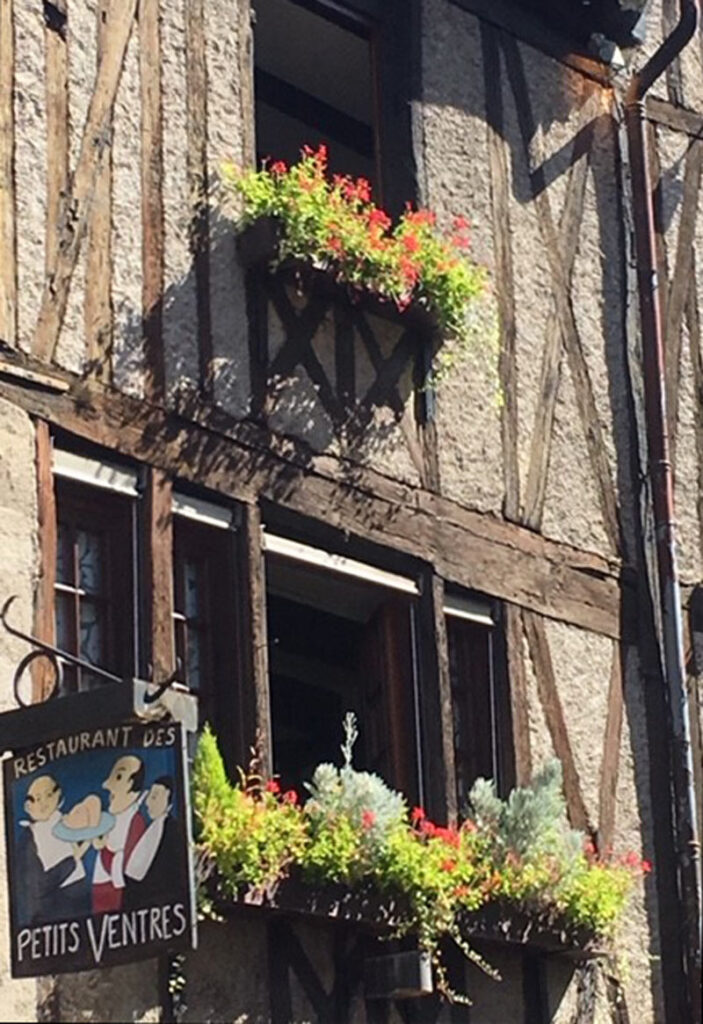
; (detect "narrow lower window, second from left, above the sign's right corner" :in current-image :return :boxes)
[173,516,235,728]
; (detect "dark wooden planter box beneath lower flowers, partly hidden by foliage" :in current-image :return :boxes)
[207,874,608,961]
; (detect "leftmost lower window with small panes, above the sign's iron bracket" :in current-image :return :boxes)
[55,480,134,693]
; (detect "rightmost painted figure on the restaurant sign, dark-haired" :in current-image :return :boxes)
[125,775,182,907]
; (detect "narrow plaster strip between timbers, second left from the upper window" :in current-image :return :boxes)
[160,0,199,392]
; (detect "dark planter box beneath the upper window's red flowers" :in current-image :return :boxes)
[237,217,438,341]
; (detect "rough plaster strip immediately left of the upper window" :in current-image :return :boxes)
[206,0,250,417]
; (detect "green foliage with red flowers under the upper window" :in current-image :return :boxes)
[216,145,490,370]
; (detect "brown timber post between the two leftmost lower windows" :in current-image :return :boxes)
[145,468,176,680]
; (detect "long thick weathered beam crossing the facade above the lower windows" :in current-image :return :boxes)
[0,372,620,637]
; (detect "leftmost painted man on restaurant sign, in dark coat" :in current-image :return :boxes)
[17,775,88,924]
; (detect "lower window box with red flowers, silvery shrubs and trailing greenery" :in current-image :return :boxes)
[193,716,651,998]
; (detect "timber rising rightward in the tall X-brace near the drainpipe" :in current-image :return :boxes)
[522,111,596,529]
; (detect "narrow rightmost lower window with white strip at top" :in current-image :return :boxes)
[444,593,501,808]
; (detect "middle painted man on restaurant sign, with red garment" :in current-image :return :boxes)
[92,754,146,913]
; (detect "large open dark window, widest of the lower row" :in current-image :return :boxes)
[266,554,419,800]
